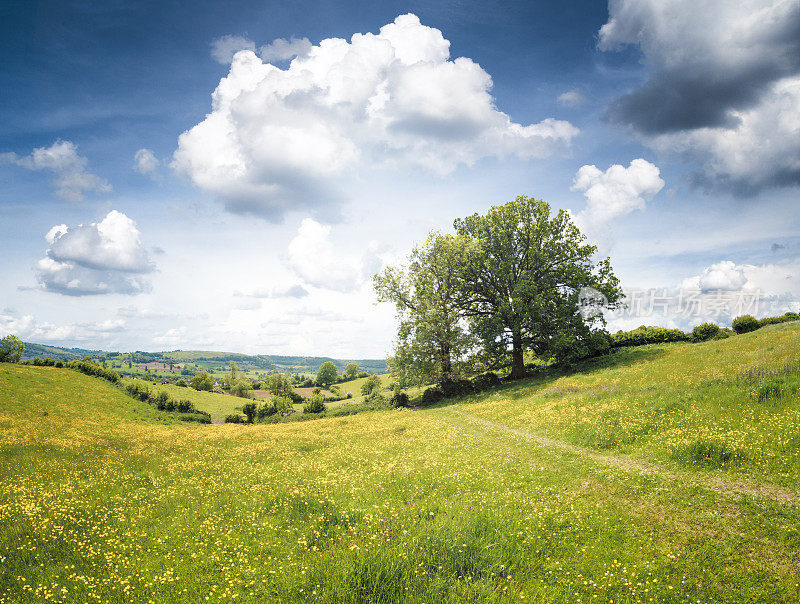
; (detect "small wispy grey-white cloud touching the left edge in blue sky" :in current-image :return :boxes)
[0,140,111,201]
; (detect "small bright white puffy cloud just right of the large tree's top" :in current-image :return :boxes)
[572,158,664,229]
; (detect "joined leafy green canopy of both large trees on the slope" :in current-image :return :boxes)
[374,196,622,383]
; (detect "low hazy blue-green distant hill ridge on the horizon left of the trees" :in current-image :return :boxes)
[23,342,387,373]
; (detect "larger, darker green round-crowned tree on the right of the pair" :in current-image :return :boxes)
[454,196,621,378]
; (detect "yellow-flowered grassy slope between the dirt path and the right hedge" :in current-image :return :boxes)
[450,322,800,485]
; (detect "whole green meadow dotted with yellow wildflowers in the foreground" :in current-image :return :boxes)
[0,323,800,603]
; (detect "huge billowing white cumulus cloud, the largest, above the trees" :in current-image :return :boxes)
[172,14,578,220]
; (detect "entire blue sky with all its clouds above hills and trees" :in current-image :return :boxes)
[0,0,800,357]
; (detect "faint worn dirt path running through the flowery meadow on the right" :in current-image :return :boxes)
[439,406,800,505]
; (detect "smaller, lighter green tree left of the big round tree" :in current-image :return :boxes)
[374,232,474,383]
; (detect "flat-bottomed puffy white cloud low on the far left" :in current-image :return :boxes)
[36,210,155,296]
